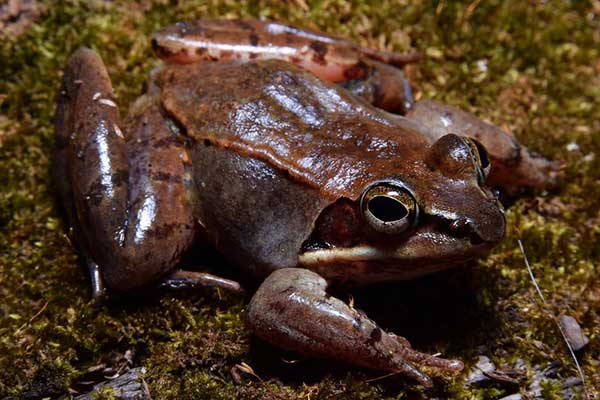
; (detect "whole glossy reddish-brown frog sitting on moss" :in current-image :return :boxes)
[54,19,560,387]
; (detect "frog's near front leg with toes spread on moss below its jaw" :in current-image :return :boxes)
[248,268,463,387]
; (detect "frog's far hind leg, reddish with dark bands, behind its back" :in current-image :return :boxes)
[152,19,421,114]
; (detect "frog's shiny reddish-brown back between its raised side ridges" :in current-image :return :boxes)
[155,61,427,199]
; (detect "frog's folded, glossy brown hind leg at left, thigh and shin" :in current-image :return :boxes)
[56,49,194,290]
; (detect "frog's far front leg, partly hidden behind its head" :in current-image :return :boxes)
[406,100,560,193]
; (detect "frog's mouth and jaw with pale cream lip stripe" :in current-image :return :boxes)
[299,224,497,284]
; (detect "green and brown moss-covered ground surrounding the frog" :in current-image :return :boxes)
[0,0,600,399]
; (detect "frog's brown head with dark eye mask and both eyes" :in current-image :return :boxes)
[300,134,505,283]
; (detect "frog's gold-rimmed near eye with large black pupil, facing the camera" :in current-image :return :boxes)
[360,182,418,234]
